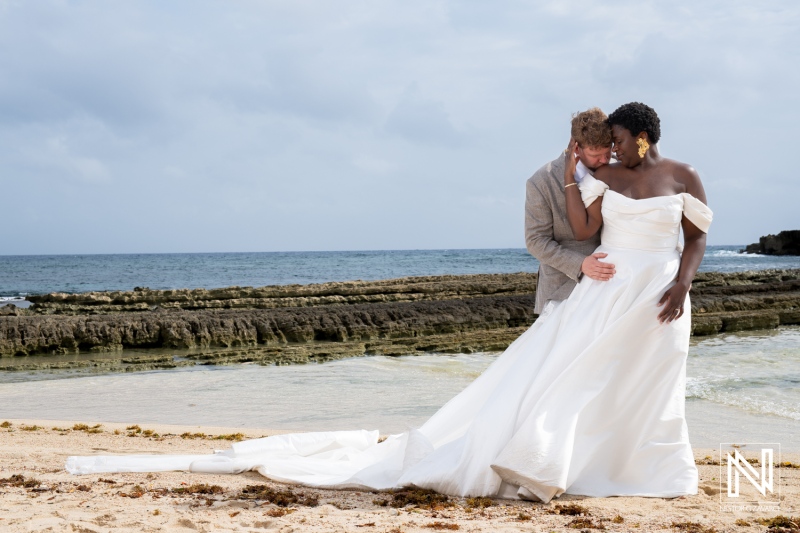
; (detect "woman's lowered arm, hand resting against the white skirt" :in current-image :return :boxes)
[658,166,707,324]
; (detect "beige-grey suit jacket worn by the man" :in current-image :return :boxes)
[525,154,600,314]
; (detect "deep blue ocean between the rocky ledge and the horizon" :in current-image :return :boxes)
[0,245,800,301]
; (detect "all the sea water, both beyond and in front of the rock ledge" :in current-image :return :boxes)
[0,245,800,451]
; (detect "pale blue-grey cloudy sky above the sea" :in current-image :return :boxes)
[0,0,800,254]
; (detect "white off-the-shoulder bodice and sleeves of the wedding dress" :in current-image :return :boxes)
[580,175,713,252]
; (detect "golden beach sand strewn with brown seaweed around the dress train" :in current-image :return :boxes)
[0,419,800,533]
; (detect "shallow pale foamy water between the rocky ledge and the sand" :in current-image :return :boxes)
[0,327,800,451]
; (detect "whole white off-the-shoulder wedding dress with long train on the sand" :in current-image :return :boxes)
[66,176,712,502]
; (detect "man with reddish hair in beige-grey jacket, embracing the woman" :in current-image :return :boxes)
[525,107,615,314]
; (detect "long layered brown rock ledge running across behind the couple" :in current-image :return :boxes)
[0,269,800,372]
